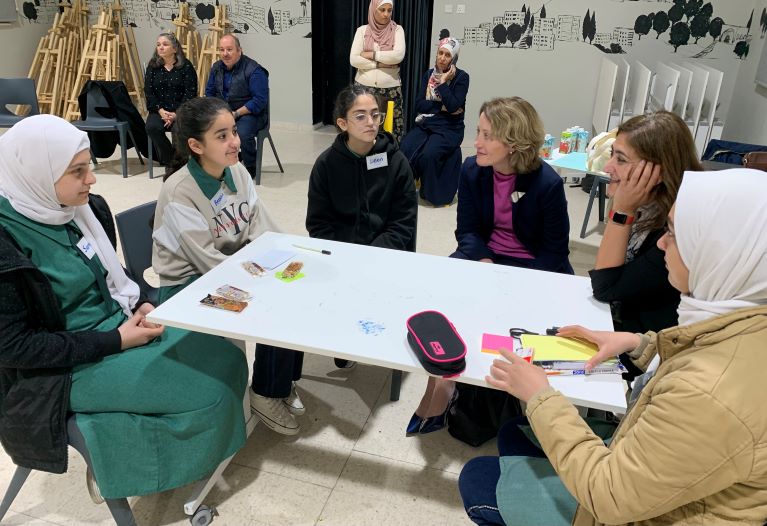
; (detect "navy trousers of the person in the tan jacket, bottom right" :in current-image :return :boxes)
[458,416,546,526]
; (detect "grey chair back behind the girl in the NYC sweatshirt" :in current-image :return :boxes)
[115,201,159,305]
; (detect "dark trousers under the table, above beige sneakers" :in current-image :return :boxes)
[252,343,304,398]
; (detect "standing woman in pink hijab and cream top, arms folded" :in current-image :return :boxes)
[349,0,405,143]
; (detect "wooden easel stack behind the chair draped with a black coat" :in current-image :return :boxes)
[64,0,146,120]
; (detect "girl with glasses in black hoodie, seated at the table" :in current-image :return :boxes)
[306,84,418,367]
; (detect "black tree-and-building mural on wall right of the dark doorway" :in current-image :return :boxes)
[456,0,756,60]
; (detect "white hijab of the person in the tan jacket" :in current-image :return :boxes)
[674,168,767,325]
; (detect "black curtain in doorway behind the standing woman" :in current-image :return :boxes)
[312,0,436,129]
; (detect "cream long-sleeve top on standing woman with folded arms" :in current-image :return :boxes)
[349,24,405,88]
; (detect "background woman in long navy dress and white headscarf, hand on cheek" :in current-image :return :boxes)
[400,37,469,206]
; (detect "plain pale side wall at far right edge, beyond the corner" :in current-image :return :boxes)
[722,0,767,145]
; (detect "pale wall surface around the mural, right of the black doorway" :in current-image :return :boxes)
[432,0,764,148]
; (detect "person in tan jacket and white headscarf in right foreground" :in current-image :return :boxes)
[459,169,767,526]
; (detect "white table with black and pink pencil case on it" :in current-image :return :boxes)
[147,232,626,514]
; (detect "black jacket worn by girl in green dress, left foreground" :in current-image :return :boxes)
[0,209,120,473]
